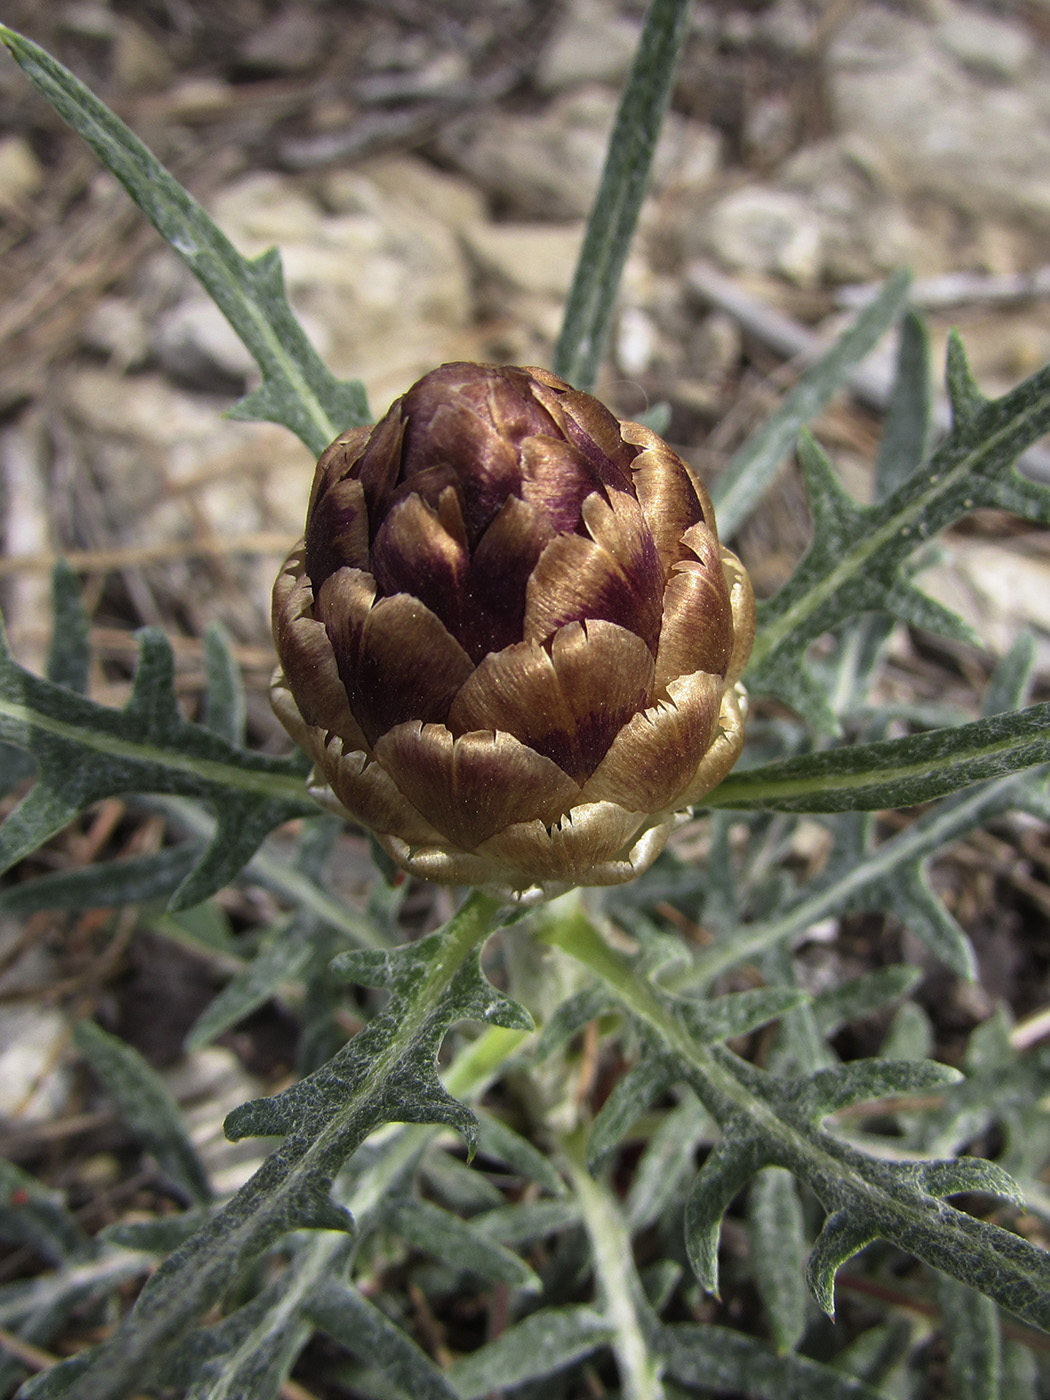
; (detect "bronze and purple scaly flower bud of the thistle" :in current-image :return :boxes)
[273,364,755,897]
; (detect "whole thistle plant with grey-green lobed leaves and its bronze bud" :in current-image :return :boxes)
[0,8,1050,1400]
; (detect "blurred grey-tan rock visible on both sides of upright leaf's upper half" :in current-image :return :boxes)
[442,85,721,221]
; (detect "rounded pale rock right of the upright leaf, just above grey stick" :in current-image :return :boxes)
[697,185,822,287]
